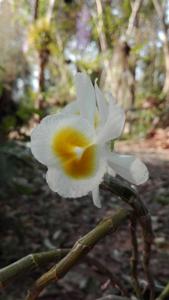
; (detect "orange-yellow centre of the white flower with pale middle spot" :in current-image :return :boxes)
[51,127,97,179]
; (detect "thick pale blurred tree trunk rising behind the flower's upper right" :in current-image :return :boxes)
[99,0,143,110]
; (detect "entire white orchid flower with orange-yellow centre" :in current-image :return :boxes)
[31,73,148,207]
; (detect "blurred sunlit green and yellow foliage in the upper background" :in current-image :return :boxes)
[0,0,166,141]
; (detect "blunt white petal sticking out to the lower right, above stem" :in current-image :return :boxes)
[108,152,149,185]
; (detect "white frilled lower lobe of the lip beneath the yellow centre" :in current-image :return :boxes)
[46,160,106,198]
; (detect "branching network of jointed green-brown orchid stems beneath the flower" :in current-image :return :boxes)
[0,178,154,300]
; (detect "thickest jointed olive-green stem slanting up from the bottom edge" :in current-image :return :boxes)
[26,209,131,300]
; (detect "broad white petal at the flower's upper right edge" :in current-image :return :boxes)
[97,102,125,143]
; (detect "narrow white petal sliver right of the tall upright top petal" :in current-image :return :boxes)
[95,82,108,125]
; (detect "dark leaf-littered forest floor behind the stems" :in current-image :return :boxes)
[0,138,169,300]
